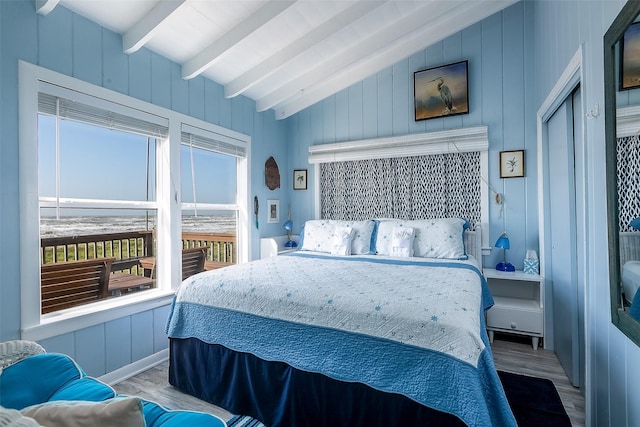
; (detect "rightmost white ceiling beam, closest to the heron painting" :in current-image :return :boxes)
[270,0,515,119]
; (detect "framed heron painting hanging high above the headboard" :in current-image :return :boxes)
[413,61,469,121]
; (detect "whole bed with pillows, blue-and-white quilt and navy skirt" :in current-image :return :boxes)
[167,218,516,427]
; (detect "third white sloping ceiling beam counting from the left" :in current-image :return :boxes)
[182,0,295,79]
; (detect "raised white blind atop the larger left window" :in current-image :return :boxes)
[38,88,169,139]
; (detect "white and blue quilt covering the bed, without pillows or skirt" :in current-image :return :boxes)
[167,251,516,426]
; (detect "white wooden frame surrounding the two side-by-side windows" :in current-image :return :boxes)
[18,61,251,340]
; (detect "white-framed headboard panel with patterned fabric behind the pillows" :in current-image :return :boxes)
[309,126,489,263]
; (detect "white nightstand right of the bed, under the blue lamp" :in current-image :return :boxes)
[484,268,544,350]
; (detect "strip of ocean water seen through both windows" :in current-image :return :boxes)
[40,215,236,237]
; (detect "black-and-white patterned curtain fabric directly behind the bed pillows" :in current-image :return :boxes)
[320,151,481,229]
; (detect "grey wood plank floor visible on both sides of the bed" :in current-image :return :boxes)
[113,334,585,427]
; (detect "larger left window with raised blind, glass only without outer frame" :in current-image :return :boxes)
[38,84,168,314]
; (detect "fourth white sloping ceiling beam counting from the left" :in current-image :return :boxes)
[224,0,387,98]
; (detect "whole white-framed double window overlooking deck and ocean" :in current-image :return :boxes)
[19,61,250,340]
